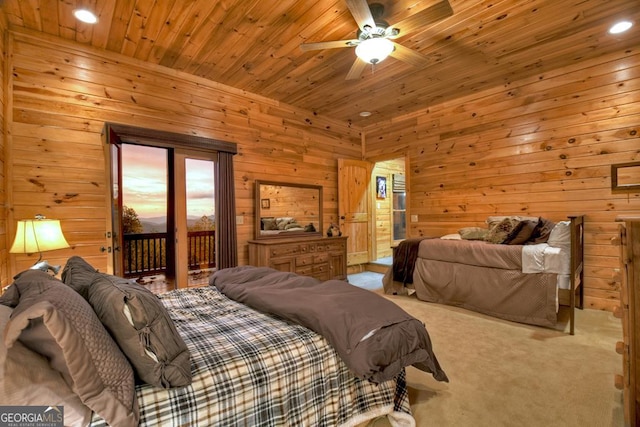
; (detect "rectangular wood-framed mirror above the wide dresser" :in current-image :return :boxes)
[256,181,322,239]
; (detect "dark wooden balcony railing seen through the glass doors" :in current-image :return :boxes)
[123,230,216,277]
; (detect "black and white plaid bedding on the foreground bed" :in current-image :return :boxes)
[91,287,415,427]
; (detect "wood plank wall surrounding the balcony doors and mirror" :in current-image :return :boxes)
[8,30,362,273]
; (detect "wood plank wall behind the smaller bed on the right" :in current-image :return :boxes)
[364,49,640,310]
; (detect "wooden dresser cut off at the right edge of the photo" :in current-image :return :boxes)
[615,217,640,426]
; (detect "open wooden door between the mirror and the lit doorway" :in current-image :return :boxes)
[338,159,373,266]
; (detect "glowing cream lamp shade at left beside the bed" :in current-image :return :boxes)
[9,217,69,254]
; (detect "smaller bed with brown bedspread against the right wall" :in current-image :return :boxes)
[383,215,584,335]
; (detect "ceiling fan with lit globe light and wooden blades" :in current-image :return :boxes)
[300,0,453,80]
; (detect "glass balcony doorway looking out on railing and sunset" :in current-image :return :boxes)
[114,143,215,292]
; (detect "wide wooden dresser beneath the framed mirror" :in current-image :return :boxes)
[248,237,347,281]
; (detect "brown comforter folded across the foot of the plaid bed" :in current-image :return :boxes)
[209,266,449,383]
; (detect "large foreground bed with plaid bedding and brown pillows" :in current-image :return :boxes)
[0,257,448,426]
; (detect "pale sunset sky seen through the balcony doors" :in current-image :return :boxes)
[122,144,214,218]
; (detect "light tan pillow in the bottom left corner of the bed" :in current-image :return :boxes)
[0,306,91,427]
